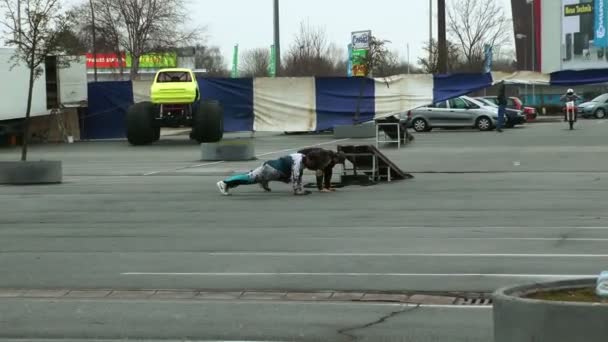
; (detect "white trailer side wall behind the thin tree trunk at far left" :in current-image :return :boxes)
[0,48,48,121]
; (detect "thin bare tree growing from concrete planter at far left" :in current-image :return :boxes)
[0,0,70,161]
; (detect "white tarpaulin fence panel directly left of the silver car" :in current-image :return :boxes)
[374,74,433,119]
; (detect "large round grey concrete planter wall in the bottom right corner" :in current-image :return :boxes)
[493,279,608,342]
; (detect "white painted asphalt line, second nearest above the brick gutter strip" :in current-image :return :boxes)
[207,252,608,259]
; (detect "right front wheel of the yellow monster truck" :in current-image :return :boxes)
[191,101,224,143]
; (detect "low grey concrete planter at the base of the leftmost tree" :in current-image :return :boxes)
[0,161,63,185]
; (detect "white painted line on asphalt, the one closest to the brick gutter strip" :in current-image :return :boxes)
[121,272,597,279]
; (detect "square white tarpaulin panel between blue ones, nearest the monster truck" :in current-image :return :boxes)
[253,77,317,132]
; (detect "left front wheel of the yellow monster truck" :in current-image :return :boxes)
[127,102,160,146]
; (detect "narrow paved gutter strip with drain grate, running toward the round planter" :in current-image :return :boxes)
[0,289,480,306]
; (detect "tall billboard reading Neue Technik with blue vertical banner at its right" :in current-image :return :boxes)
[560,0,608,70]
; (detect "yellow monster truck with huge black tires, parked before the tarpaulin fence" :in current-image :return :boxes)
[127,69,224,145]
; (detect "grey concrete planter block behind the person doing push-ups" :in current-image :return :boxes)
[201,139,256,161]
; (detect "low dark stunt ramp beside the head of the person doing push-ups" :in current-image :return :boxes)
[338,145,414,182]
